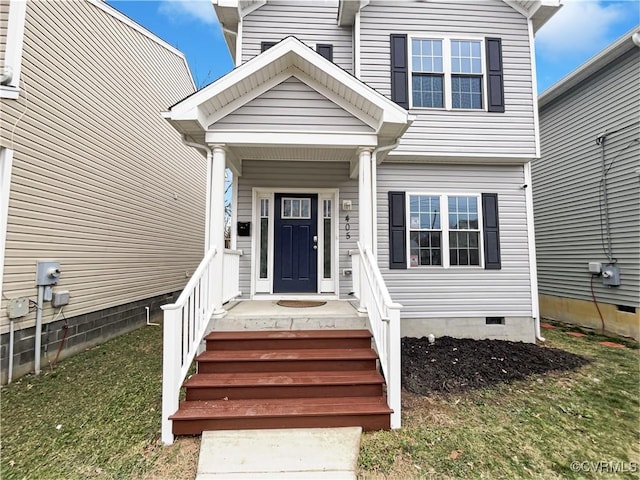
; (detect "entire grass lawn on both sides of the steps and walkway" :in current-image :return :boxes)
[0,320,640,480]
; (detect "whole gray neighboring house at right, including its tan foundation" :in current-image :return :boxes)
[533,28,640,339]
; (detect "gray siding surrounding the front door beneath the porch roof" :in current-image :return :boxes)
[237,160,358,298]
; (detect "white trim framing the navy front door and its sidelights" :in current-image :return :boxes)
[250,187,340,298]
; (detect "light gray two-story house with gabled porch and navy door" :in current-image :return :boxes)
[160,0,559,444]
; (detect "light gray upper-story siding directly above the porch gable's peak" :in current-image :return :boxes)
[242,0,353,72]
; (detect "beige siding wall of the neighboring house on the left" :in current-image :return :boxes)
[0,2,206,332]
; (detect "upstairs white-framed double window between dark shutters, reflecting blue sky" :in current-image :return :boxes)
[411,38,484,110]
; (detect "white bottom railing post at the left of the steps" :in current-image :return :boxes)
[162,305,182,445]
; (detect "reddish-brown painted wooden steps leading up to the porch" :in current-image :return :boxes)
[170,330,392,435]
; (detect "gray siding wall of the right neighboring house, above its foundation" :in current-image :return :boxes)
[533,47,640,307]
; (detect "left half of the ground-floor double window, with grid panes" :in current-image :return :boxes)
[409,195,442,267]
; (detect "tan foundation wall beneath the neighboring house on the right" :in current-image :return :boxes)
[540,295,640,340]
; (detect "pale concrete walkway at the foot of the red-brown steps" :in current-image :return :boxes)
[196,427,362,480]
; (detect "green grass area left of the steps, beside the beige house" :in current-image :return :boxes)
[0,327,162,480]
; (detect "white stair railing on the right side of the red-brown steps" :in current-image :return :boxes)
[352,242,402,428]
